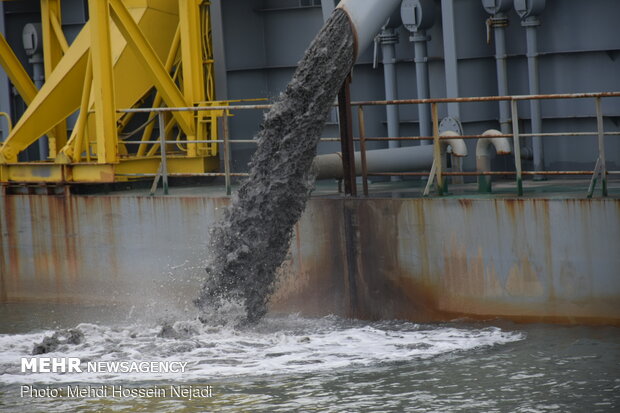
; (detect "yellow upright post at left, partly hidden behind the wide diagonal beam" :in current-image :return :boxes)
[41,0,69,158]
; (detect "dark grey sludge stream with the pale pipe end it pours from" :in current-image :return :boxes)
[195,0,400,322]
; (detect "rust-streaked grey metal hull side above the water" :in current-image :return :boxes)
[0,195,620,325]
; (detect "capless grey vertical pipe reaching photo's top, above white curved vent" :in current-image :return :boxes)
[441,0,461,120]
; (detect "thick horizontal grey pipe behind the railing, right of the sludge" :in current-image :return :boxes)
[314,146,433,179]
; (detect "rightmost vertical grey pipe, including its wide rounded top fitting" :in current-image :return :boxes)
[515,0,545,181]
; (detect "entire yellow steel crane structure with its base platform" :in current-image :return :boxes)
[0,0,226,184]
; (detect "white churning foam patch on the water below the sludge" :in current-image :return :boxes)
[0,316,525,384]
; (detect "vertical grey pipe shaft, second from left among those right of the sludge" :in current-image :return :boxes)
[411,30,433,145]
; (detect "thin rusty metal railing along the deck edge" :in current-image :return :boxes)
[118,92,620,197]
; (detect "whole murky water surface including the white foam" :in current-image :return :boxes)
[0,304,620,412]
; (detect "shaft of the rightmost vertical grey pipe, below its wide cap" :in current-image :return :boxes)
[521,16,545,175]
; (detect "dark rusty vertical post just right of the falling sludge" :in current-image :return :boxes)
[338,76,357,196]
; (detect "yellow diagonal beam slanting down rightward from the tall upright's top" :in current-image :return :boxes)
[108,0,195,136]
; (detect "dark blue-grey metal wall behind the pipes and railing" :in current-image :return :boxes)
[222,0,620,169]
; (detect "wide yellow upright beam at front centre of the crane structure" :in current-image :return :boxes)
[88,0,118,163]
